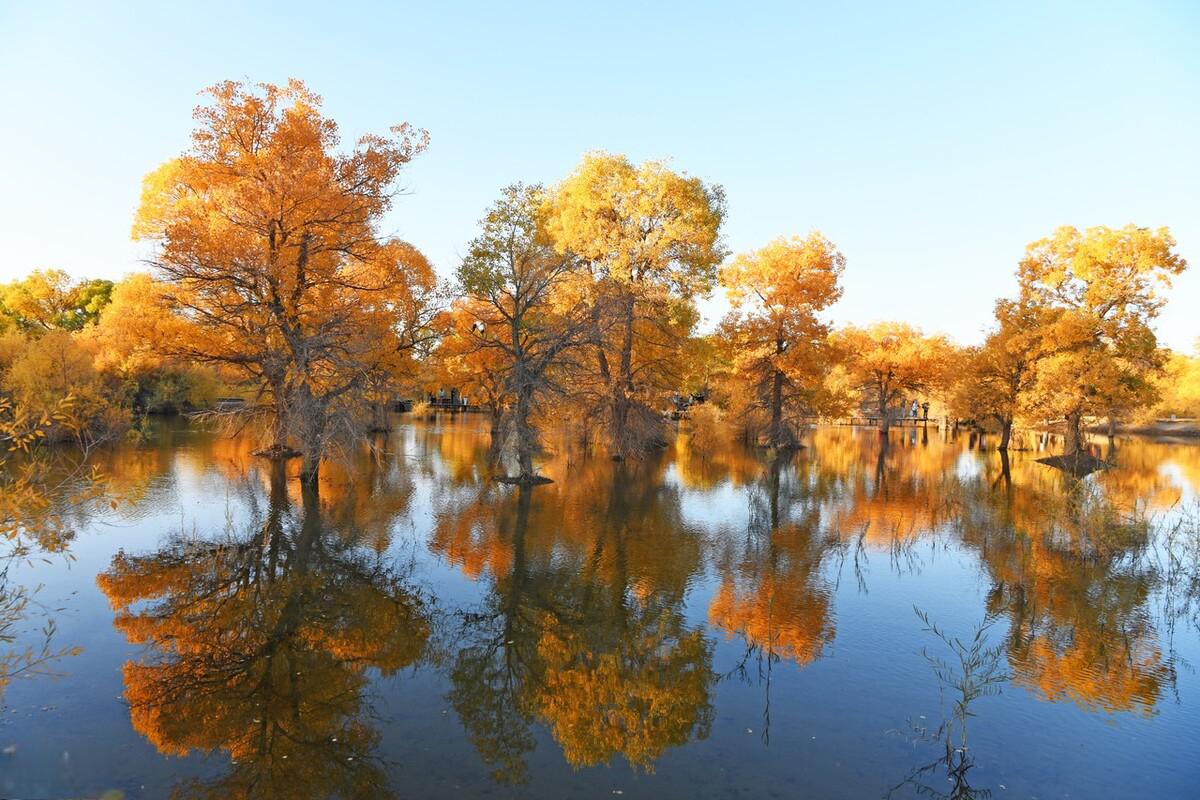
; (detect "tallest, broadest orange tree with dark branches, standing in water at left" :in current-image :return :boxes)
[133,80,427,483]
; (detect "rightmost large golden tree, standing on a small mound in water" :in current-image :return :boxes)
[1018,224,1187,455]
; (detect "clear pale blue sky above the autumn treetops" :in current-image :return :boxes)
[0,0,1200,349]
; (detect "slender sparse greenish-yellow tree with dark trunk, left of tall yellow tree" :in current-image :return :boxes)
[458,184,590,483]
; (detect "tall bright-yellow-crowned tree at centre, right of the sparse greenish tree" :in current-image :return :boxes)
[546,152,725,458]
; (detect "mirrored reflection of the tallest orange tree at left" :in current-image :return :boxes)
[97,468,430,798]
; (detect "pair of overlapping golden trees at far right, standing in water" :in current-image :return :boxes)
[954,224,1187,453]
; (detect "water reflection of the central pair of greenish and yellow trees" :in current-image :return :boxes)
[434,462,714,783]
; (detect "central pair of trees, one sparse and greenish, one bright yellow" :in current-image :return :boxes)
[448,154,725,482]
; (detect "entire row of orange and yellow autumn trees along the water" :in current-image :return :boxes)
[0,80,1200,483]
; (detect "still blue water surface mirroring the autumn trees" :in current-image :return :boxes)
[0,415,1200,799]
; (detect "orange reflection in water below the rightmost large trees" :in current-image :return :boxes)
[960,453,1175,714]
